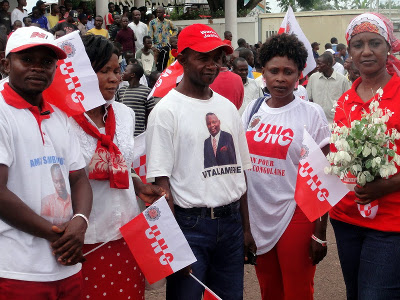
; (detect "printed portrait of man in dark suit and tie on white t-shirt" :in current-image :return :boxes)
[204,112,236,168]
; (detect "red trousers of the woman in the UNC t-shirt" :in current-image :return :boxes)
[256,207,315,300]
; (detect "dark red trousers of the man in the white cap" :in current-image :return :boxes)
[0,272,83,300]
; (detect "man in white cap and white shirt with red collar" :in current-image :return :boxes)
[0,27,92,300]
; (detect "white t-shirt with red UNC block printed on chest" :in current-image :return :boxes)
[242,97,330,254]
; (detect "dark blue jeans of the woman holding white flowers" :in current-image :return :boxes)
[331,219,400,300]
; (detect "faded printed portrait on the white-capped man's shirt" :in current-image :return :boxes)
[41,164,72,225]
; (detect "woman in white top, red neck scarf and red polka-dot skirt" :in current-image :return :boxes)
[73,35,164,300]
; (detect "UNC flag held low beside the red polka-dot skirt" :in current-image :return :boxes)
[120,197,196,284]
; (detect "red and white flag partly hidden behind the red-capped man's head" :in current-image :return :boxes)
[147,60,183,99]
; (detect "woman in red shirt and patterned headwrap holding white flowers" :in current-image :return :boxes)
[330,13,400,300]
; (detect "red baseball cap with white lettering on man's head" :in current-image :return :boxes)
[178,24,233,54]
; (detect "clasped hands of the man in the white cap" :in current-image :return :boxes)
[51,217,87,266]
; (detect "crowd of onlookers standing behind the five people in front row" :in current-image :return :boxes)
[0,0,359,130]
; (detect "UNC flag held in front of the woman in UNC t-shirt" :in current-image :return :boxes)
[294,129,349,222]
